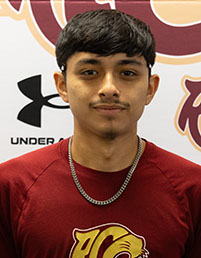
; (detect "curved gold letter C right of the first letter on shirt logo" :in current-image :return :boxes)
[89,226,128,258]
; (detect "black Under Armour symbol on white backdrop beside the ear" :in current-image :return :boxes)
[17,75,70,127]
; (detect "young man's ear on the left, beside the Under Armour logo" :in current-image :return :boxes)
[54,72,68,103]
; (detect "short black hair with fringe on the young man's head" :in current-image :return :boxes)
[56,9,155,71]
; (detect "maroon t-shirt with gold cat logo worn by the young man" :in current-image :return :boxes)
[0,140,201,258]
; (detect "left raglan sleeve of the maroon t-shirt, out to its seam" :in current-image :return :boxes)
[0,143,61,258]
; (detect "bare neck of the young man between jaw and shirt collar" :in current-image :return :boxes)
[71,133,145,172]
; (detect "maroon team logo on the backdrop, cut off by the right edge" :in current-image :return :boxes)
[178,79,201,147]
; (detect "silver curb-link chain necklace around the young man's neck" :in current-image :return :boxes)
[68,137,142,206]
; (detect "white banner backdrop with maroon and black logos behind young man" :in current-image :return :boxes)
[0,0,201,164]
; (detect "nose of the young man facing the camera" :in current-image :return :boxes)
[98,73,120,99]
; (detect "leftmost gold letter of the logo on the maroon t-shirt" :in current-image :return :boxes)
[72,229,100,258]
